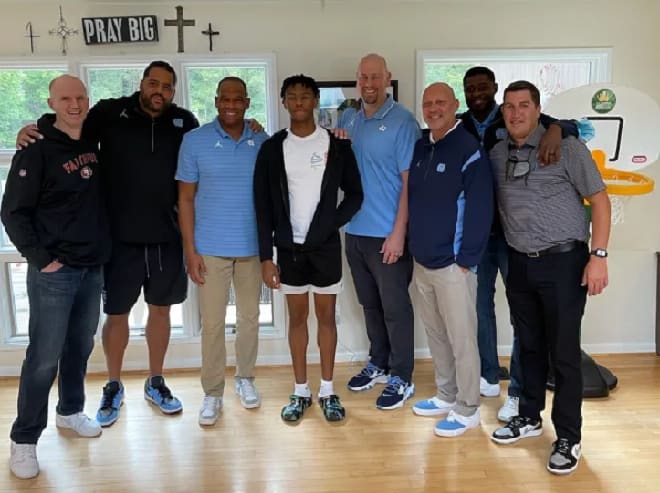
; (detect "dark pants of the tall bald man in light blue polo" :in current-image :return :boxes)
[346,233,415,383]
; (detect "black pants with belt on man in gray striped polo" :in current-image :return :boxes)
[506,245,589,442]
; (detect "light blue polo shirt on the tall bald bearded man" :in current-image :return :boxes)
[337,96,421,238]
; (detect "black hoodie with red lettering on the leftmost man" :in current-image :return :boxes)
[0,115,110,270]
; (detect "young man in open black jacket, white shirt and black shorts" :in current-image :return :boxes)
[254,75,362,421]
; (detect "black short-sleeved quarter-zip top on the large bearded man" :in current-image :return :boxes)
[83,93,199,243]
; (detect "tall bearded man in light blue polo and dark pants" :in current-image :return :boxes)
[338,54,421,409]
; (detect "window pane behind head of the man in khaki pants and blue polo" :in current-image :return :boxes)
[186,67,272,130]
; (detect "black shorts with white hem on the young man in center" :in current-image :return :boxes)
[277,242,341,288]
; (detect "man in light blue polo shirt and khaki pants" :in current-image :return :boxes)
[176,77,268,426]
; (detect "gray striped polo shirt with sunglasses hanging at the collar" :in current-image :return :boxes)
[490,125,605,253]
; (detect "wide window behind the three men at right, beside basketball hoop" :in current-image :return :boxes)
[416,48,611,117]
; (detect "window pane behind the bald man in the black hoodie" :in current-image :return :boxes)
[0,68,66,150]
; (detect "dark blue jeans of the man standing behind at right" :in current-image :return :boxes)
[477,233,522,397]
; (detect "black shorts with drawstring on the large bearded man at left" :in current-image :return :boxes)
[103,241,188,315]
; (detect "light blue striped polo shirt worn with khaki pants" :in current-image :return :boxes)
[176,118,268,257]
